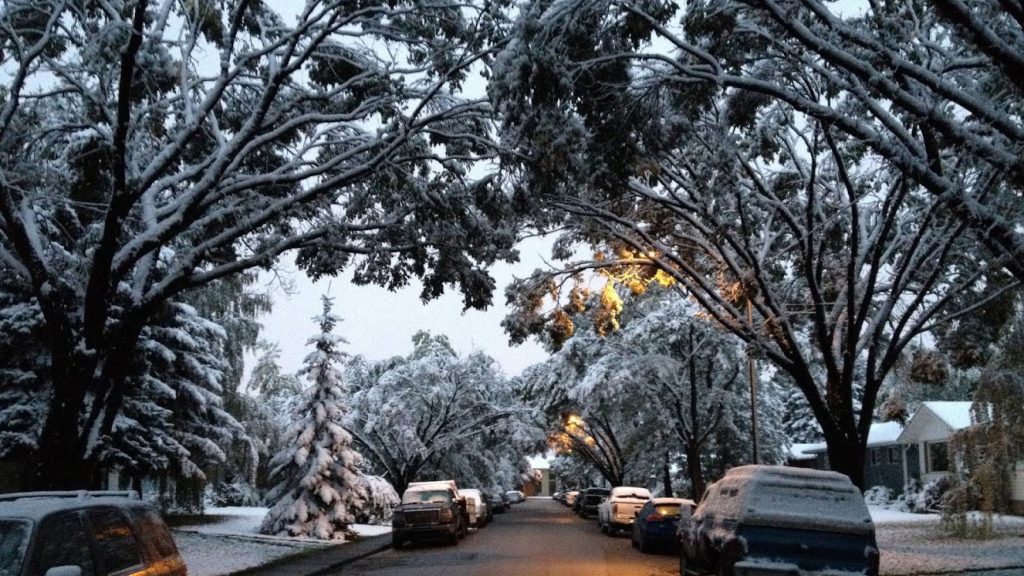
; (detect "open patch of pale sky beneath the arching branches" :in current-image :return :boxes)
[260,234,550,376]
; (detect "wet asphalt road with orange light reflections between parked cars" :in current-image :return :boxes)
[332,499,679,576]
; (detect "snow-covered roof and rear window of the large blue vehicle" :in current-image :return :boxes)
[698,465,874,534]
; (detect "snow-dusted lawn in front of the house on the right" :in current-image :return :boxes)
[868,506,1024,576]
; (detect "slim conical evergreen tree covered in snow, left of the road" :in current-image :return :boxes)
[260,296,367,540]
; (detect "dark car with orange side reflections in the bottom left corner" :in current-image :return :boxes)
[0,490,187,576]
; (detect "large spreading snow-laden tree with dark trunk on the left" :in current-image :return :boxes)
[0,0,515,488]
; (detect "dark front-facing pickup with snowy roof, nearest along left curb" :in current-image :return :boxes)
[391,481,469,548]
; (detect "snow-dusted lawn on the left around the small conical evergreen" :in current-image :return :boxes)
[174,507,391,576]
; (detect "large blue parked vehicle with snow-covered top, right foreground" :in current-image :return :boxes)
[677,465,880,576]
